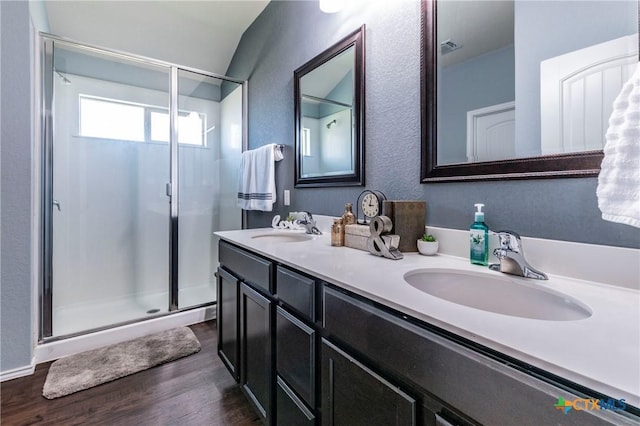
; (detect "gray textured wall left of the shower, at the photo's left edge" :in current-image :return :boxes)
[0,1,32,372]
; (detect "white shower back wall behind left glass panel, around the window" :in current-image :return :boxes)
[53,74,169,316]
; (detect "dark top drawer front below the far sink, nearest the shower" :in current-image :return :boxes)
[218,241,273,294]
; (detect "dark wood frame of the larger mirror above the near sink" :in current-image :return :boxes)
[420,0,624,183]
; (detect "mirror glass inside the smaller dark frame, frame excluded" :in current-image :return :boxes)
[300,46,355,177]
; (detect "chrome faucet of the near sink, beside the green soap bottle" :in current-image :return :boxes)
[489,231,549,280]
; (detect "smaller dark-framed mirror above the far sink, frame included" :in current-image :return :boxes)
[293,25,365,187]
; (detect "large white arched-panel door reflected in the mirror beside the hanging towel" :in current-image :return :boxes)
[540,34,638,155]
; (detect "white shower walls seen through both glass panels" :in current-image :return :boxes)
[52,64,243,336]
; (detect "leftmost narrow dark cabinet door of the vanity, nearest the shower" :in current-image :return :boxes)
[216,268,240,382]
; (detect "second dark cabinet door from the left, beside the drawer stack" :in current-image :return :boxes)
[240,283,275,424]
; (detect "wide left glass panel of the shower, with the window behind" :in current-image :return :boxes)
[44,40,171,336]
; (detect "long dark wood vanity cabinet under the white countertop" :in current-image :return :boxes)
[218,241,638,426]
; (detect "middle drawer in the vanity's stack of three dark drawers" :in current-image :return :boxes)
[276,306,316,407]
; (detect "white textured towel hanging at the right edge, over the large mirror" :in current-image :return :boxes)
[596,62,640,228]
